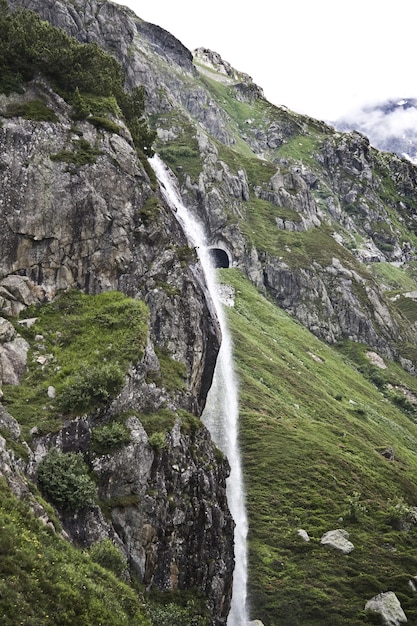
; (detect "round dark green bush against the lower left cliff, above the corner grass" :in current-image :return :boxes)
[38,449,97,510]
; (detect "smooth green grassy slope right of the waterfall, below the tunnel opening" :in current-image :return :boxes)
[222,270,417,626]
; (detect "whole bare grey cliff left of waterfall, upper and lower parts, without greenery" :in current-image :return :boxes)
[0,3,233,624]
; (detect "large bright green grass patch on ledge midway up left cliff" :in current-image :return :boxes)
[3,291,148,438]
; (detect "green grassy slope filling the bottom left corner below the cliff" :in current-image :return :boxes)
[0,480,152,626]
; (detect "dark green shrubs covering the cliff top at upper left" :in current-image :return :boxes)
[0,0,156,156]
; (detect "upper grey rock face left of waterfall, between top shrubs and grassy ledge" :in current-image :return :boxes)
[0,82,219,412]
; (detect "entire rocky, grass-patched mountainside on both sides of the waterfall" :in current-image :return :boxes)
[0,0,417,626]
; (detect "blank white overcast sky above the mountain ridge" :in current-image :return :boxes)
[111,0,417,120]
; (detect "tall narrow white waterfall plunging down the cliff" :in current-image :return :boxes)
[150,155,248,626]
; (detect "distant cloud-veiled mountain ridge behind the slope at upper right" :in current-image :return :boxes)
[333,98,417,163]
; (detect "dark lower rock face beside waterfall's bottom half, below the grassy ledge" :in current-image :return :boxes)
[26,415,234,626]
